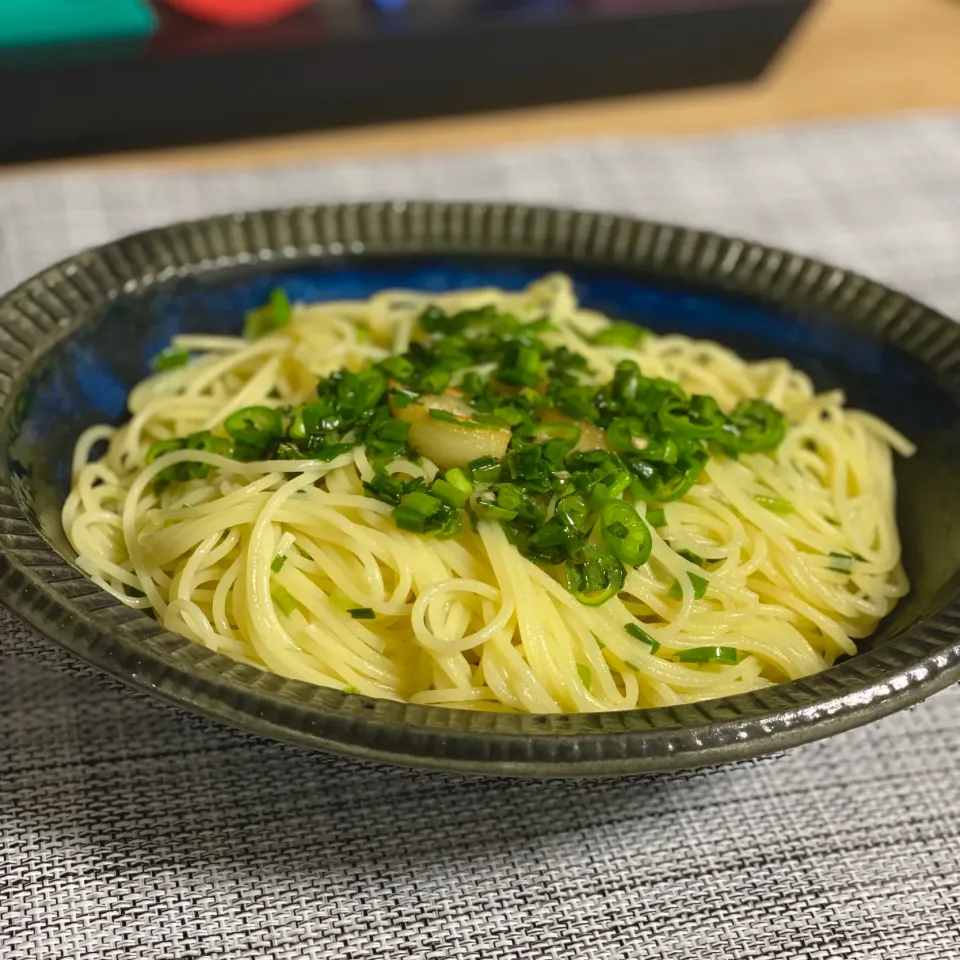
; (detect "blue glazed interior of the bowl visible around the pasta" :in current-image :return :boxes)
[8,258,960,660]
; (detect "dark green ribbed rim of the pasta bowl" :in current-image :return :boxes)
[0,202,960,775]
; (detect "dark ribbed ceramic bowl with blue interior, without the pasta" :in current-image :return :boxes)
[0,203,960,775]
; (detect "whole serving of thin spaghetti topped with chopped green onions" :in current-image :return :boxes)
[63,275,912,713]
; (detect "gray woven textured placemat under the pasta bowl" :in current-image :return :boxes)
[0,116,960,960]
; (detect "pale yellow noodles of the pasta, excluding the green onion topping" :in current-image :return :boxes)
[63,275,912,713]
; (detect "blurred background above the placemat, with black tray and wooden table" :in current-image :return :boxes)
[0,0,960,164]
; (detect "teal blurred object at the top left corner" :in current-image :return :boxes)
[0,0,157,47]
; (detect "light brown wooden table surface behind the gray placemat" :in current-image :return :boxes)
[5,0,960,174]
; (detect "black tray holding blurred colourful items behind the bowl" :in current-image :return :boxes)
[0,0,812,162]
